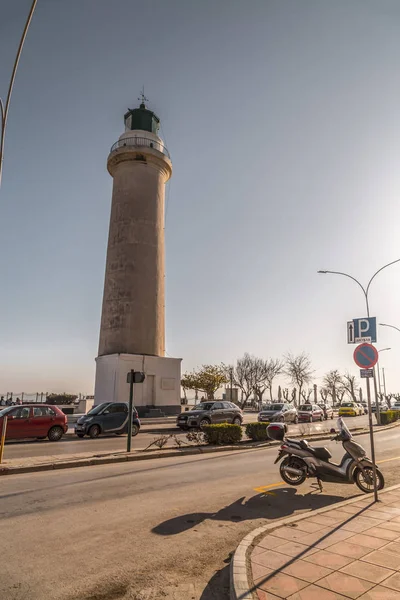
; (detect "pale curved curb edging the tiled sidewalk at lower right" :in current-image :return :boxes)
[229,483,400,600]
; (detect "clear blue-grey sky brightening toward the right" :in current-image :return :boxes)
[0,0,400,393]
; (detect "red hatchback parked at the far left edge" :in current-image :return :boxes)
[0,404,68,442]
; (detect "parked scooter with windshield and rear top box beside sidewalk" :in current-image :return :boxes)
[267,417,385,493]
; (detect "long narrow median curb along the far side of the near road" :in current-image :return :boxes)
[0,421,400,477]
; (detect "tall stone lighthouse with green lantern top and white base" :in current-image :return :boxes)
[95,95,181,416]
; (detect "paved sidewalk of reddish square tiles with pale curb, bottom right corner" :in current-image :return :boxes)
[231,485,400,600]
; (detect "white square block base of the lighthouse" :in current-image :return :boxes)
[94,354,182,417]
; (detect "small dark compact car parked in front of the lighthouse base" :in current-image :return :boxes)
[75,402,140,438]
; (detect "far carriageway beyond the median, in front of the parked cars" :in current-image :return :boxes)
[4,414,368,460]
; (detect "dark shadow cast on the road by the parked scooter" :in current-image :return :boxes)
[152,487,343,535]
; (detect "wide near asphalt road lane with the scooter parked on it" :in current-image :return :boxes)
[0,428,400,600]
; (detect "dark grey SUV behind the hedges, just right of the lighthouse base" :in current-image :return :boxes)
[176,400,243,430]
